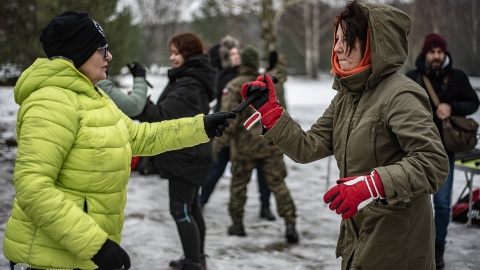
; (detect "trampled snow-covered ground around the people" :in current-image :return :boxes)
[0,75,480,270]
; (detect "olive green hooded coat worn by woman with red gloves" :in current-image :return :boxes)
[264,3,448,270]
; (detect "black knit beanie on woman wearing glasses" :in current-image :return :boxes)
[40,10,107,68]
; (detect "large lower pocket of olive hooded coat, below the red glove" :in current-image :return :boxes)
[353,204,411,269]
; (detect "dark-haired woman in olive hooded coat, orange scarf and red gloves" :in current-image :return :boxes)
[242,1,448,270]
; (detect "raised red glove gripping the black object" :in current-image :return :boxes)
[241,74,283,130]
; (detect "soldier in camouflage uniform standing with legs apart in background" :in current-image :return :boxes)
[222,47,298,243]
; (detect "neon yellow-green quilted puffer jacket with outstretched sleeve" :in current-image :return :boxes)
[3,58,209,269]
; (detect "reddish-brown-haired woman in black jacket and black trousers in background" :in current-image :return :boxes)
[138,33,215,269]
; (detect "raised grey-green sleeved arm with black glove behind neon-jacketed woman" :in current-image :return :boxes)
[97,62,148,118]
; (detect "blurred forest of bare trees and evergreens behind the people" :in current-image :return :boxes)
[0,0,480,85]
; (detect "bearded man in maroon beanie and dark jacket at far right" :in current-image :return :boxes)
[407,33,480,269]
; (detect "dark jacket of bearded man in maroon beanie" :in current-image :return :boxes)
[407,52,480,148]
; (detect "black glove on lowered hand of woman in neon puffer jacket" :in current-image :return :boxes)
[92,239,131,270]
